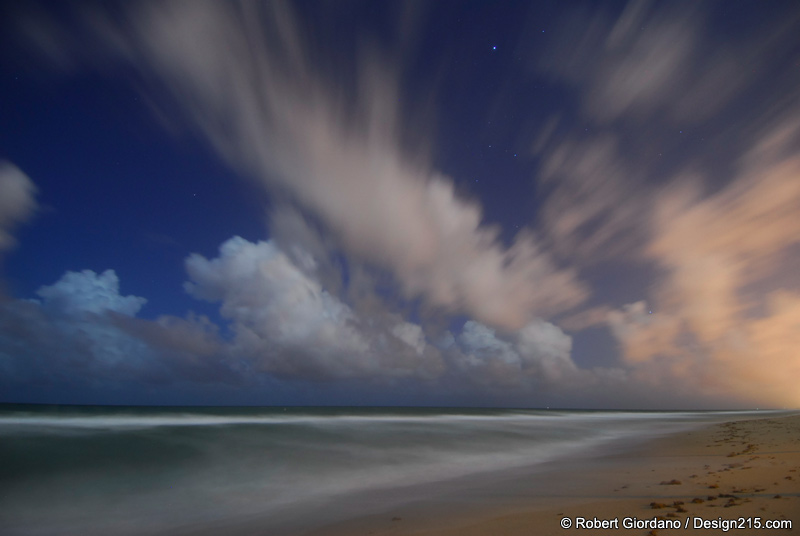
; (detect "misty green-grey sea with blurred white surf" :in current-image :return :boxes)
[0,405,780,536]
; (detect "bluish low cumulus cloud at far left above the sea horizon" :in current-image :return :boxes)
[0,270,258,402]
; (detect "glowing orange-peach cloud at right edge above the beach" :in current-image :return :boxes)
[609,112,800,406]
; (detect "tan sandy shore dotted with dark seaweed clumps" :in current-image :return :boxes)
[308,415,800,536]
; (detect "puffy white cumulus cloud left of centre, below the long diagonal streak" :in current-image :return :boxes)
[186,237,441,380]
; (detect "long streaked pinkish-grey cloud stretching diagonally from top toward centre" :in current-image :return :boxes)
[10,2,588,328]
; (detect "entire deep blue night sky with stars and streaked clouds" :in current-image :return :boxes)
[0,0,800,409]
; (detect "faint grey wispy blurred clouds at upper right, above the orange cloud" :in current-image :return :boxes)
[533,0,800,266]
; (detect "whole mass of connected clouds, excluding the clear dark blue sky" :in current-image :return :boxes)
[6,0,800,407]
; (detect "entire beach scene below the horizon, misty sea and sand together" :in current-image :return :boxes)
[0,406,800,536]
